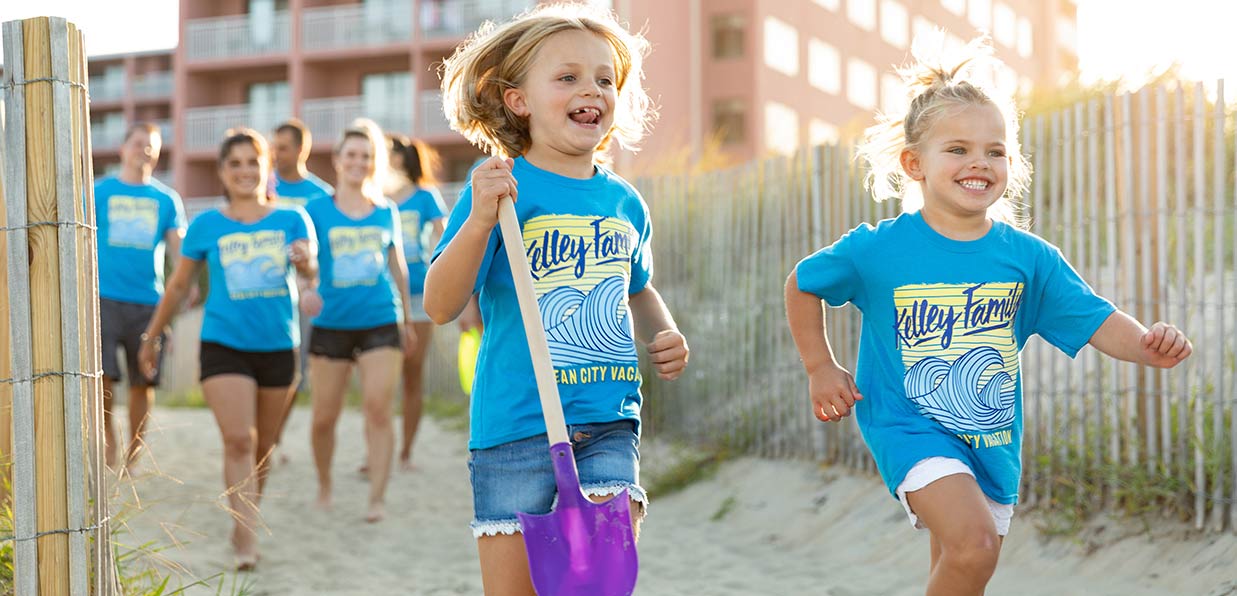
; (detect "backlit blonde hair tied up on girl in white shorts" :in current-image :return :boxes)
[857,31,1030,228]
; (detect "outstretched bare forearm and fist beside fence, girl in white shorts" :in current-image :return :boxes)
[1090,310,1194,368]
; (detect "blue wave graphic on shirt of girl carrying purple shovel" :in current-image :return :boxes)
[537,276,637,366]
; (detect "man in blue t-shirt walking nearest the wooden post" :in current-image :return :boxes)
[94,122,186,466]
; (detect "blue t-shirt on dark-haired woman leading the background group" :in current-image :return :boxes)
[181,206,313,352]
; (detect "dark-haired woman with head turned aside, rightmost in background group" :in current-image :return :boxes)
[387,134,447,470]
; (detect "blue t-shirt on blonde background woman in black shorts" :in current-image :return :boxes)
[306,197,403,330]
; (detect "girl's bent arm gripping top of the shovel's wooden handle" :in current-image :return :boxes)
[424,157,517,325]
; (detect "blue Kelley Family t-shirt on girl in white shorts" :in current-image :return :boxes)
[795,213,1113,503]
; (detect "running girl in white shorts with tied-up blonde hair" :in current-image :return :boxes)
[785,38,1191,595]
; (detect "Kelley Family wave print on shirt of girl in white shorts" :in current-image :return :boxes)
[893,282,1023,448]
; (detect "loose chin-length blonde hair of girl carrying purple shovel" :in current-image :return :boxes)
[440,4,656,157]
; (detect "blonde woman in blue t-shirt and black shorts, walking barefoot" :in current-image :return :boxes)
[306,119,416,522]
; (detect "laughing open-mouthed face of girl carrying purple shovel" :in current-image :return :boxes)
[503,30,619,167]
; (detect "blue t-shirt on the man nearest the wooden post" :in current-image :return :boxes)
[94,176,184,305]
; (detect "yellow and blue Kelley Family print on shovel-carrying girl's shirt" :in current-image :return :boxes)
[523,215,640,385]
